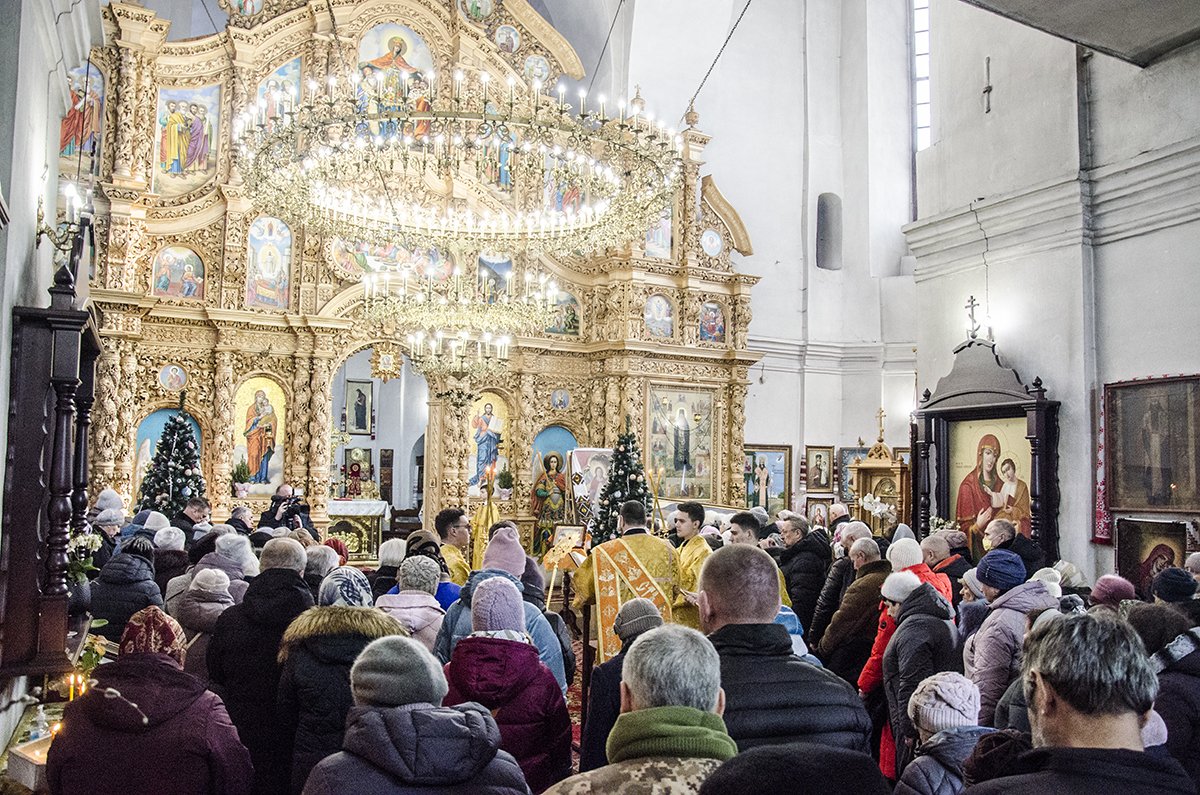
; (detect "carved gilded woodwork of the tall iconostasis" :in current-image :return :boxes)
[91,0,757,532]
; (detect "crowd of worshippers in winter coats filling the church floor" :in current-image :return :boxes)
[47,486,1200,795]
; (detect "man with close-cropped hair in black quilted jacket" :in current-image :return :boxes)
[697,545,871,753]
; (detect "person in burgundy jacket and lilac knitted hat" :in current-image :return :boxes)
[443,576,571,793]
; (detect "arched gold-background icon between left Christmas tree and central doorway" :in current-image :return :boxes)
[233,376,287,495]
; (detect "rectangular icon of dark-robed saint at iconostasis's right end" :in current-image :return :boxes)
[647,384,713,501]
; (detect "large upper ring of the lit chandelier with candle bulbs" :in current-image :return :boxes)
[234,68,682,253]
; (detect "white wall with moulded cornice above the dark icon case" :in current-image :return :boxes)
[908,0,1200,575]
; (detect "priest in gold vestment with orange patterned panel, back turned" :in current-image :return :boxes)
[574,501,679,664]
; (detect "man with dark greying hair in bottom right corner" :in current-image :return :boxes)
[966,614,1195,795]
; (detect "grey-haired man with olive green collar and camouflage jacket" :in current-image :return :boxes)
[546,629,729,795]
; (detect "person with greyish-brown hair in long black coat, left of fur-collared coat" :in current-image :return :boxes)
[206,536,313,793]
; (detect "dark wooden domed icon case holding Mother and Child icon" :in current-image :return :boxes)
[911,339,1058,561]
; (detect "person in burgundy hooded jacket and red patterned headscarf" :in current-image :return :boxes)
[46,606,254,795]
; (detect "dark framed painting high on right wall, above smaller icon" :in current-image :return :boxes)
[1104,376,1200,513]
